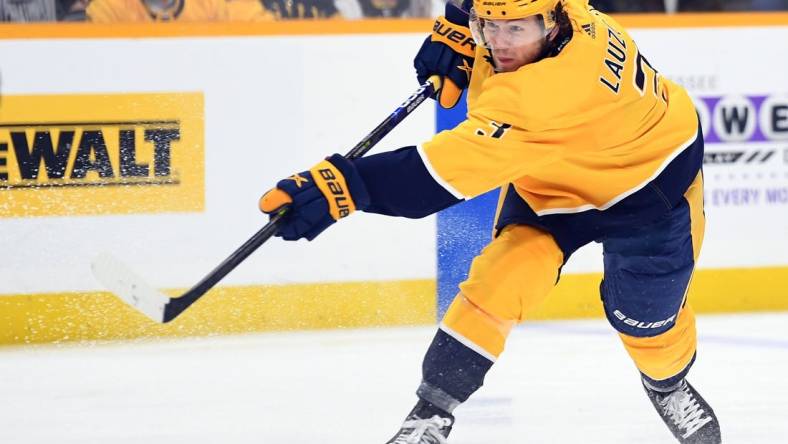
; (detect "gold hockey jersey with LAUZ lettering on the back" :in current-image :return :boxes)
[419,0,698,216]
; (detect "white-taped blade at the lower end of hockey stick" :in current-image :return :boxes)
[90,253,170,323]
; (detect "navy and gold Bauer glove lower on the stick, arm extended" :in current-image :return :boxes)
[260,154,369,241]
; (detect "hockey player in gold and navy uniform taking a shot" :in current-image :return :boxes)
[260,0,721,444]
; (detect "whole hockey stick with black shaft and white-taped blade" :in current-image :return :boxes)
[91,75,441,323]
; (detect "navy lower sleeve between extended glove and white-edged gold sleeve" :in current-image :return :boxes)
[354,146,462,219]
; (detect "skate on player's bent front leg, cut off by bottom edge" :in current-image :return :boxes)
[386,400,454,444]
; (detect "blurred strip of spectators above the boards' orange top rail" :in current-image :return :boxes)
[0,0,788,23]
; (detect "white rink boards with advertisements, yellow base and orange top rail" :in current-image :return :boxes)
[0,14,788,343]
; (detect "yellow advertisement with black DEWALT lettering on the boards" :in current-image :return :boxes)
[0,92,205,217]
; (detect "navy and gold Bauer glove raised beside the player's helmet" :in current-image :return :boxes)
[413,2,476,108]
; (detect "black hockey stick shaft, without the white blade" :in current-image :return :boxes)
[163,76,440,322]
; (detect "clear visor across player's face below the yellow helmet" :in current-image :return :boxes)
[469,8,550,51]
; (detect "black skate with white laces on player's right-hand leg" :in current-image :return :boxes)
[643,379,722,444]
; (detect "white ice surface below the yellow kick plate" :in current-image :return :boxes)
[0,314,788,444]
